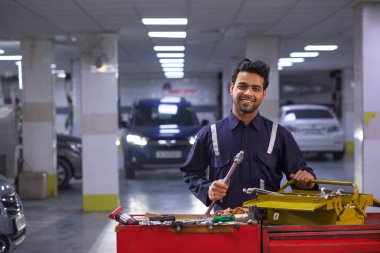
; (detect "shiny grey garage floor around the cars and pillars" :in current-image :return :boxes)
[13,153,353,253]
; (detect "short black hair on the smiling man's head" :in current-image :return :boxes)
[232,58,270,90]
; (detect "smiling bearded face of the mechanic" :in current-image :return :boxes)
[230,72,266,114]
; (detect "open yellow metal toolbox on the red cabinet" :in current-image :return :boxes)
[243,180,380,225]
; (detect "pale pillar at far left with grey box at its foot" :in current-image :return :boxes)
[19,40,57,199]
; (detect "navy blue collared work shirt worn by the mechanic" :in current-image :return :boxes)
[181,114,314,210]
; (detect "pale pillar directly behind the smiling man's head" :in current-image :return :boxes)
[245,37,280,121]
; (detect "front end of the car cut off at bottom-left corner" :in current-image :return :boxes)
[0,175,26,252]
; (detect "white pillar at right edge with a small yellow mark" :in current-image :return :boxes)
[354,3,380,204]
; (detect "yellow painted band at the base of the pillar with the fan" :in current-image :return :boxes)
[83,194,119,212]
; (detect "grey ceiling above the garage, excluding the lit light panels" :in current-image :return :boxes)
[0,0,374,77]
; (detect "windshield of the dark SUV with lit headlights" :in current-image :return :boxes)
[135,104,198,126]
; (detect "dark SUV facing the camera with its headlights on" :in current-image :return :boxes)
[123,97,207,178]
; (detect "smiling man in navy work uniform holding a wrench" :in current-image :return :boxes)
[181,59,317,211]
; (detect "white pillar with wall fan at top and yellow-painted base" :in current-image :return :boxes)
[80,33,119,211]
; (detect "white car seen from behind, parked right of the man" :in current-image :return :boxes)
[280,105,344,160]
